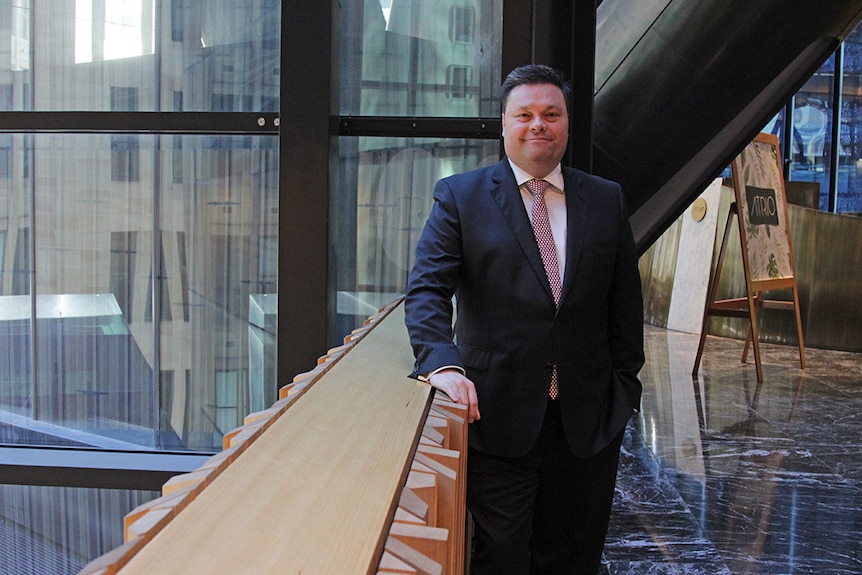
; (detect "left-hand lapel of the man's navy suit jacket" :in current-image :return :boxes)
[490,158,552,302]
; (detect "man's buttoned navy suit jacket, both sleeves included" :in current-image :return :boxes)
[404,159,644,457]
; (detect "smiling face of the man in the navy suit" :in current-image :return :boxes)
[503,84,569,178]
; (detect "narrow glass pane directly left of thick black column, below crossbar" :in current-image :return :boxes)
[159,136,278,450]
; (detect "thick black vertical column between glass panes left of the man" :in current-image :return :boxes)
[276,0,338,387]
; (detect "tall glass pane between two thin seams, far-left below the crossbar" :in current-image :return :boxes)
[31,135,160,449]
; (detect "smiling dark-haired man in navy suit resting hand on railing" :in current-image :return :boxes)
[405,65,644,575]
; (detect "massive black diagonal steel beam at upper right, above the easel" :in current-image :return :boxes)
[593,0,862,251]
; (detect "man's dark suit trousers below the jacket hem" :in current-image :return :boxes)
[467,401,624,575]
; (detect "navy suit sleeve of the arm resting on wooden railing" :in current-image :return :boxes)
[404,180,463,377]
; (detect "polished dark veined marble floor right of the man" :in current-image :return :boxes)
[605,326,862,575]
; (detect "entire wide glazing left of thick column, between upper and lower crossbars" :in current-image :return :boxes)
[0,135,278,450]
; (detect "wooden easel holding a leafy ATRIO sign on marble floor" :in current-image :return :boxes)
[692,134,805,382]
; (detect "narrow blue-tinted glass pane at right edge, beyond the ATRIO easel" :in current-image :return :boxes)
[836,26,862,214]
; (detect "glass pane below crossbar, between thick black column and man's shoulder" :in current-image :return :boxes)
[330,138,500,336]
